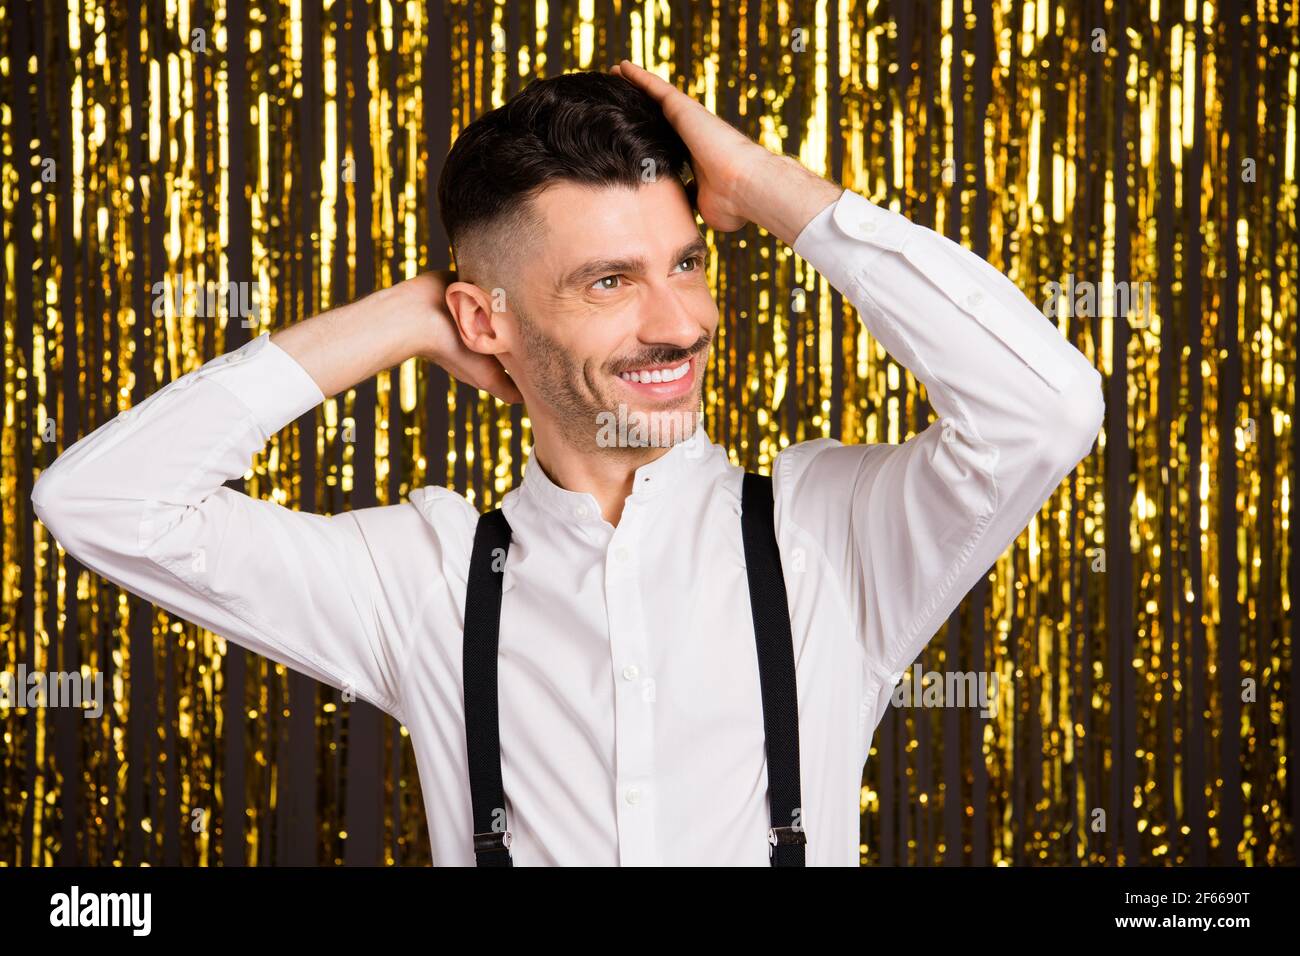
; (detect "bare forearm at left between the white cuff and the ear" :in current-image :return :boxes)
[270,273,442,398]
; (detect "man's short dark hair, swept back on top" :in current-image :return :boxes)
[438,72,689,281]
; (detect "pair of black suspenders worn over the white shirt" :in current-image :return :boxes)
[464,472,807,866]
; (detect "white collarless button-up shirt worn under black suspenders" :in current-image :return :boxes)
[33,191,1104,866]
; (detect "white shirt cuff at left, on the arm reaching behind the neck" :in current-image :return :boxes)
[195,332,325,438]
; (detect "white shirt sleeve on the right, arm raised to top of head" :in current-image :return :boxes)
[774,191,1104,727]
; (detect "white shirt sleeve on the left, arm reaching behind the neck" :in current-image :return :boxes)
[31,333,404,715]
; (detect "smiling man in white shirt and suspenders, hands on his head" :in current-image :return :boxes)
[33,61,1102,865]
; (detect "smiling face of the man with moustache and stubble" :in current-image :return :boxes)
[502,178,718,449]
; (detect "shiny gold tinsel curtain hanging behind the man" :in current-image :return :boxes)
[0,0,1300,865]
